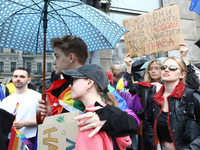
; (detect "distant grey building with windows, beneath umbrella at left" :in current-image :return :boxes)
[0,48,54,88]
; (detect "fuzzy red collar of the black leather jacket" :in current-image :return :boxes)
[153,81,185,105]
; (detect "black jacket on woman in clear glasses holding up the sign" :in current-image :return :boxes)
[124,64,199,150]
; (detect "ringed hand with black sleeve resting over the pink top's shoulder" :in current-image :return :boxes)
[75,106,106,137]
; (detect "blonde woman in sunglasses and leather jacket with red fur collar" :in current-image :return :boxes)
[145,57,200,150]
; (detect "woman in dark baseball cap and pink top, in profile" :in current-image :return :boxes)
[62,64,140,150]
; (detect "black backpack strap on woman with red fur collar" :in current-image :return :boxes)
[185,87,196,120]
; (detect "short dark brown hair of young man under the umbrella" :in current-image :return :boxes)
[51,35,89,65]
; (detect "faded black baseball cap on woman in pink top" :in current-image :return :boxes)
[62,64,109,91]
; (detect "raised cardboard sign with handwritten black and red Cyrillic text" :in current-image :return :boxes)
[122,5,184,57]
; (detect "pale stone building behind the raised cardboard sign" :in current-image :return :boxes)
[100,0,200,70]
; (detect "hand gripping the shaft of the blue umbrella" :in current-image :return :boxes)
[37,98,51,117]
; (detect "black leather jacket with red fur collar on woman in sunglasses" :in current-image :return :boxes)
[145,83,200,150]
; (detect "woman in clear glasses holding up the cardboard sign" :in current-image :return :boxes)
[124,43,199,150]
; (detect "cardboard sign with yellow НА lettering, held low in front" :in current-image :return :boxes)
[37,112,80,150]
